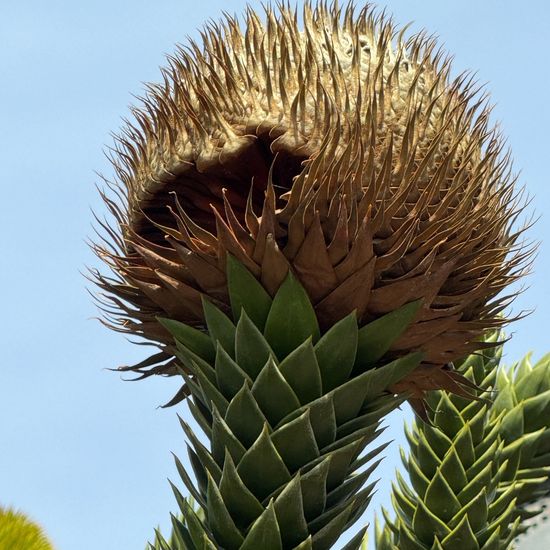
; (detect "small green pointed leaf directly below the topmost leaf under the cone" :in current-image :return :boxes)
[235,311,275,380]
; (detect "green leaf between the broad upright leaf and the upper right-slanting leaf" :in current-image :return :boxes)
[315,312,358,393]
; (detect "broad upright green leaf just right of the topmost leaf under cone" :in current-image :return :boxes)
[264,271,320,360]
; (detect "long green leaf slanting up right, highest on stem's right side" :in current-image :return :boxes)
[357,300,422,369]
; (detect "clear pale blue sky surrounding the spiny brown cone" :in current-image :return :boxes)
[0,0,550,550]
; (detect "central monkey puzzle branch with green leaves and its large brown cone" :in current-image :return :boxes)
[93,3,531,549]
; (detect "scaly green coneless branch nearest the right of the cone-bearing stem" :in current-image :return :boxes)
[375,333,534,550]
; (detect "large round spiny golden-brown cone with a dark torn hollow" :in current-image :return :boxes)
[90,4,532,404]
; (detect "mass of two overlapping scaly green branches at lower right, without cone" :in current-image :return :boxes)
[376,334,550,550]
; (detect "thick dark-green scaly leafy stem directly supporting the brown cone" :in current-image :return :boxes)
[155,258,422,550]
